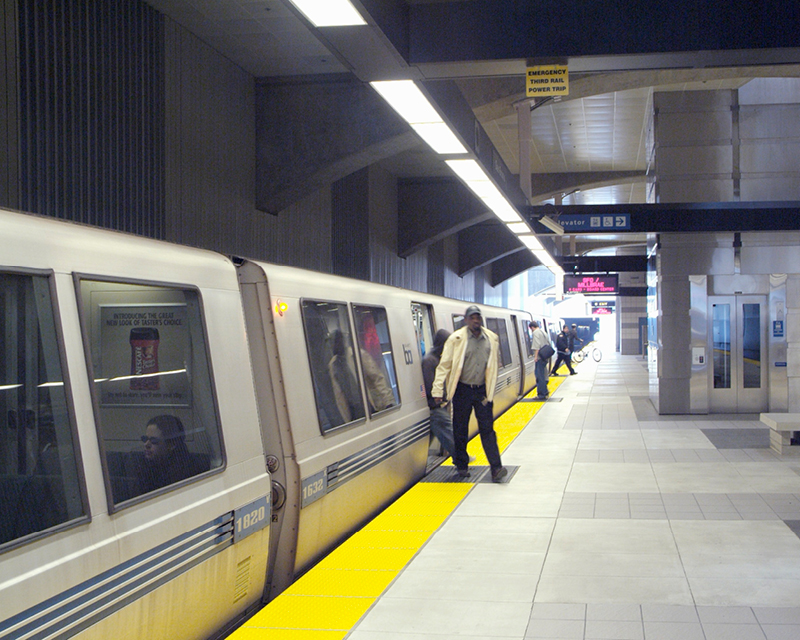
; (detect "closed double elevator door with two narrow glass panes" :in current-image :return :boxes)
[708,295,769,413]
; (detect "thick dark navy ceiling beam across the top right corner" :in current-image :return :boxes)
[408,0,800,70]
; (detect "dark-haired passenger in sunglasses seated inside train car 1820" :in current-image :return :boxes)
[137,414,198,494]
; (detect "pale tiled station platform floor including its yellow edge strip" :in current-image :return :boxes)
[230,350,800,640]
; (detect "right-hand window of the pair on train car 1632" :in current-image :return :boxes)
[353,305,400,413]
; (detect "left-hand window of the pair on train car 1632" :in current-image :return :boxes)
[302,300,366,433]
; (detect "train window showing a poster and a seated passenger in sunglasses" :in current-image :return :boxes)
[80,279,223,507]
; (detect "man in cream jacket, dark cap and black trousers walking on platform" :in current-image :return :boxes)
[431,305,508,482]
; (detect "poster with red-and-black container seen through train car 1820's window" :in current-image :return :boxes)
[95,304,191,407]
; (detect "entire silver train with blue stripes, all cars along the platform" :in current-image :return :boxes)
[0,210,535,640]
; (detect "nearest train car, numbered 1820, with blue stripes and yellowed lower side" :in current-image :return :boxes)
[0,211,270,640]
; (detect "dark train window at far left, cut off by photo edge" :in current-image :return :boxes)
[0,273,87,544]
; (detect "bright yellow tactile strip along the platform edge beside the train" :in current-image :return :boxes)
[229,379,563,640]
